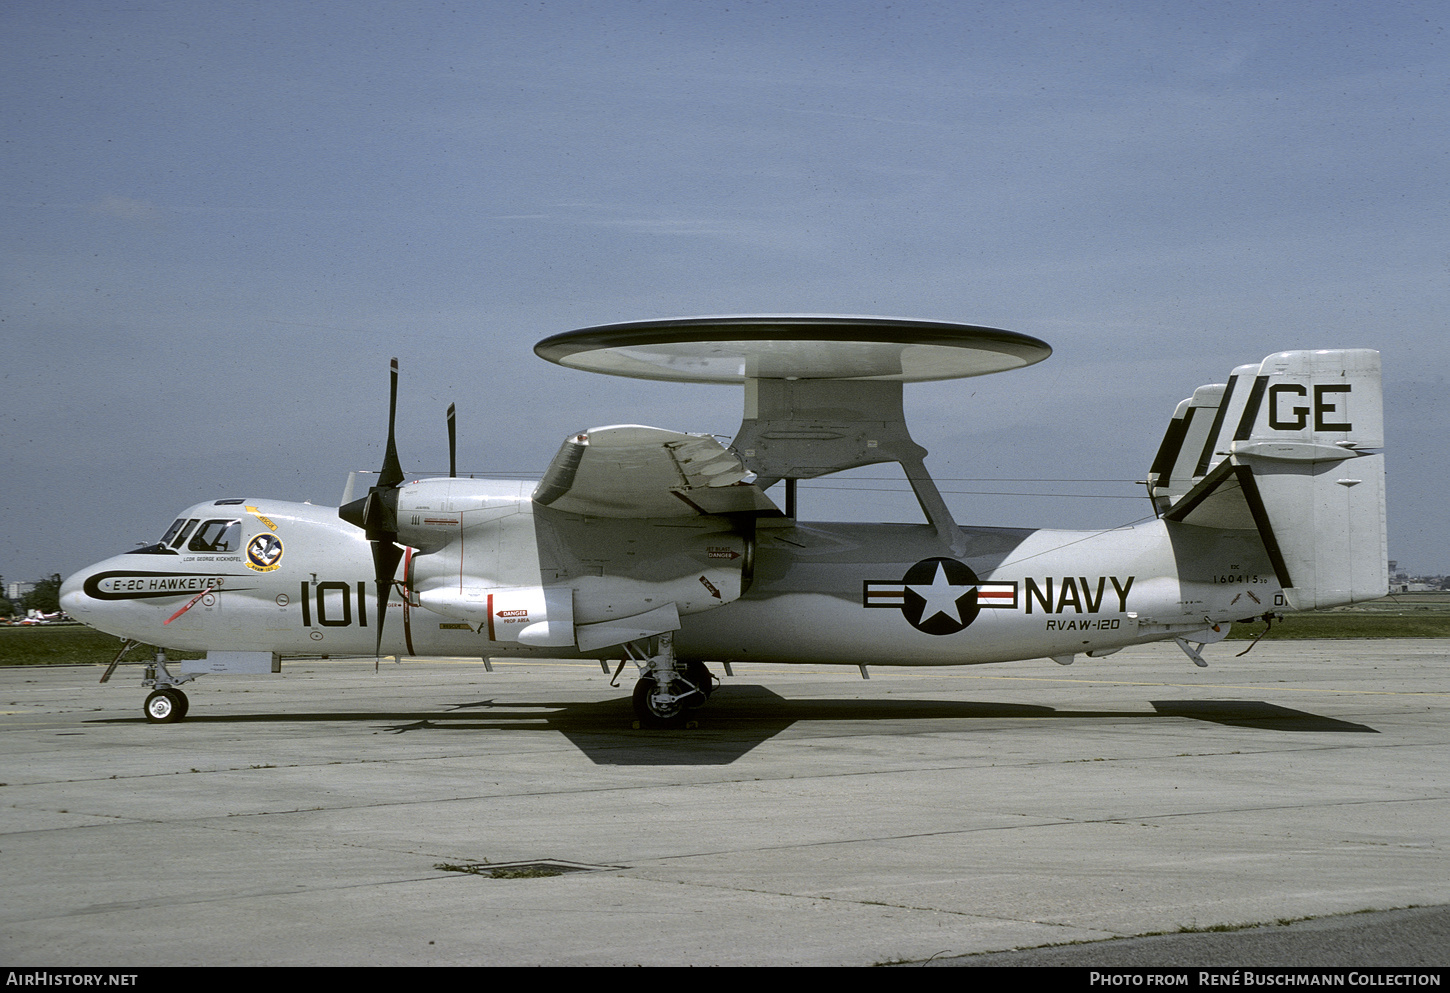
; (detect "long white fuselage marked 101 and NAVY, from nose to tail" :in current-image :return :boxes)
[62,493,1282,665]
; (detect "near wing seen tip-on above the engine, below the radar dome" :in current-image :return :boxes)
[534,425,780,518]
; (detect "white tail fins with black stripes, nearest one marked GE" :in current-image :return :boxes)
[1150,348,1389,610]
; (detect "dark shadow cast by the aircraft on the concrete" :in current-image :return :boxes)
[103,684,1379,765]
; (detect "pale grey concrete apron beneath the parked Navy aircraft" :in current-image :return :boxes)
[0,641,1450,967]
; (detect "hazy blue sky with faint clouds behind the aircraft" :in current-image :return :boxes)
[0,0,1450,580]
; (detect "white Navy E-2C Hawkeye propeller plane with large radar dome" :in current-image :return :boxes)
[61,316,1388,728]
